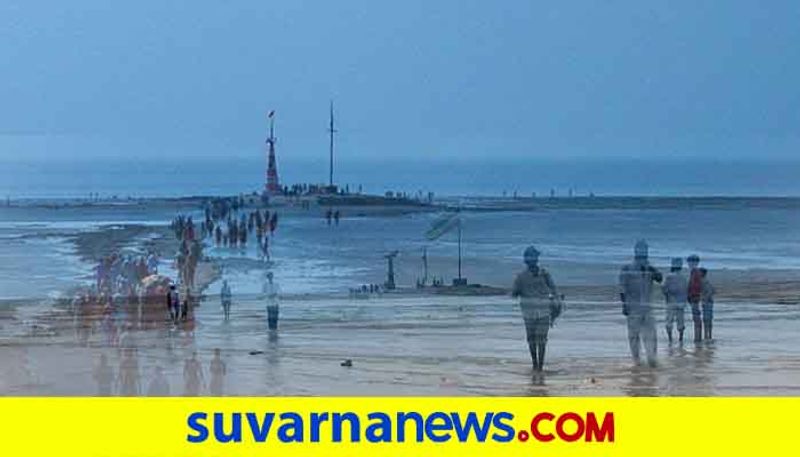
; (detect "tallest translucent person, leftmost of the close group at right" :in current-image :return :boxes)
[619,240,662,367]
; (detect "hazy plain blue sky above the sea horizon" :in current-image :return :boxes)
[0,0,800,159]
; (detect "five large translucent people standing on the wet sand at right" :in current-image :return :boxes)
[511,240,715,371]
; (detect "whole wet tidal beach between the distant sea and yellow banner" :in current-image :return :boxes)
[0,199,800,395]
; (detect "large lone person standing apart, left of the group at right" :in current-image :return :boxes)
[511,246,560,372]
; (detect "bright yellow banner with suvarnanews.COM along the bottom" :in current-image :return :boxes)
[0,398,800,457]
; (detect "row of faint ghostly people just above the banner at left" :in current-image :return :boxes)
[92,347,228,397]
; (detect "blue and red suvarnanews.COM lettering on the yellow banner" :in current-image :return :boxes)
[186,411,614,443]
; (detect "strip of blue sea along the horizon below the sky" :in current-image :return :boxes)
[0,156,800,199]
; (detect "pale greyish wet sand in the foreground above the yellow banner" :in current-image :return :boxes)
[0,266,800,396]
